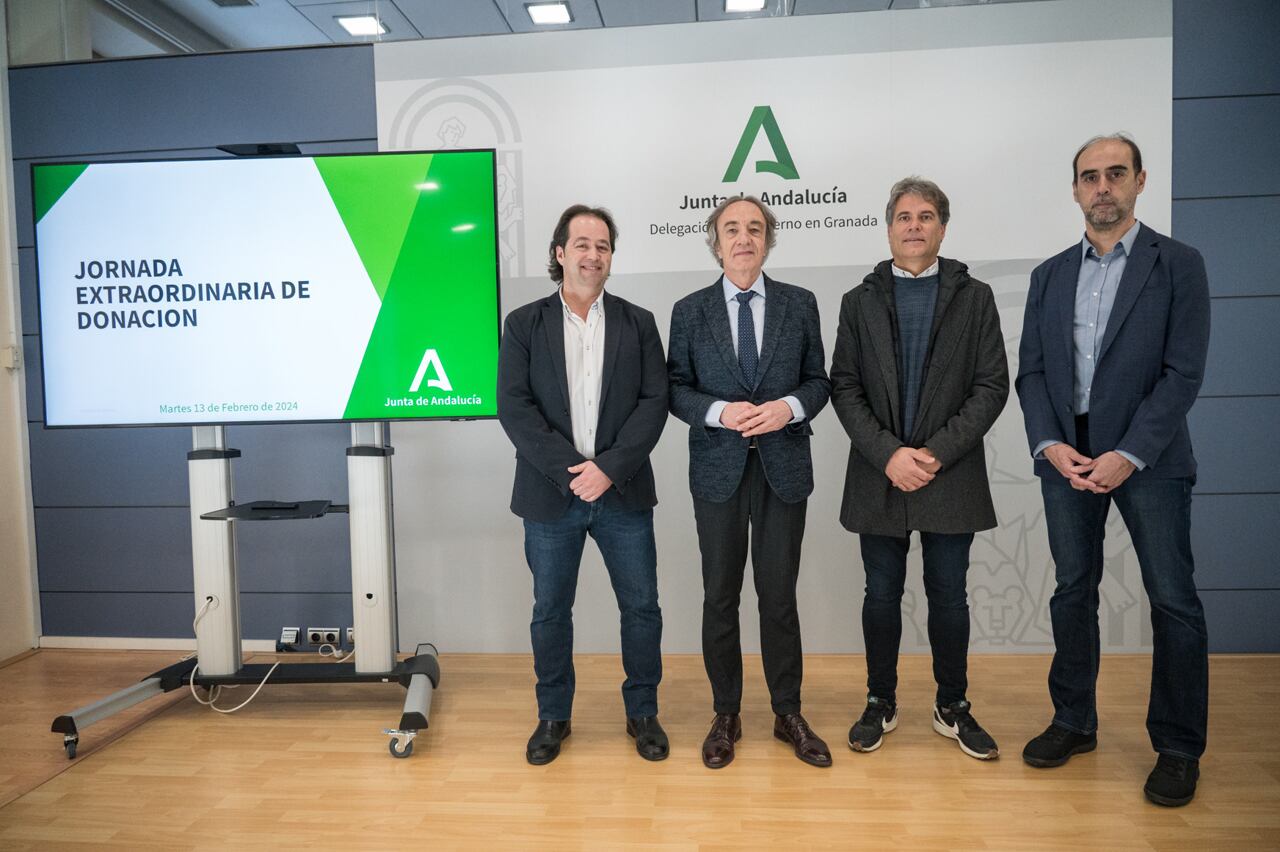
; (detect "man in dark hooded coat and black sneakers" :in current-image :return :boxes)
[831,177,1009,760]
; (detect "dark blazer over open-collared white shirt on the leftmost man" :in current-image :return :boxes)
[498,292,667,522]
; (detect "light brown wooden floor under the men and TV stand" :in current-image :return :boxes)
[0,651,1280,851]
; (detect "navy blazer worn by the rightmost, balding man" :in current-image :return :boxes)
[1016,225,1210,478]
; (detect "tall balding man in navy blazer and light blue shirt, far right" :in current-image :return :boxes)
[1016,134,1208,806]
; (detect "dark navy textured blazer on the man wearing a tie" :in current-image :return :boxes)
[667,275,831,503]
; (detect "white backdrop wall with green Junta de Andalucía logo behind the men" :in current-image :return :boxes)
[375,0,1171,652]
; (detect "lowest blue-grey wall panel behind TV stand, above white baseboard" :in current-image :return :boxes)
[40,592,351,637]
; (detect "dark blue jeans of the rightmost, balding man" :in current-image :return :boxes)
[1041,473,1208,759]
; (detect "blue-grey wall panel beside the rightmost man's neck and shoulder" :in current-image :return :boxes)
[1172,197,1280,296]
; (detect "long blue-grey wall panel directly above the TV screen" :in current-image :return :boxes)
[9,45,376,160]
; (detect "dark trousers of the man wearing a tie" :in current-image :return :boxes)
[694,450,806,715]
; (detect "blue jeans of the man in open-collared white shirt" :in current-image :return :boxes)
[525,495,662,722]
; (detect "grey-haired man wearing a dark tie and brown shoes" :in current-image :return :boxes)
[667,197,831,769]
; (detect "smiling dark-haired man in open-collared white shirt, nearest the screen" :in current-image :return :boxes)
[498,205,669,764]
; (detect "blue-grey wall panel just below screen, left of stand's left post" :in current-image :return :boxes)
[29,425,191,508]
